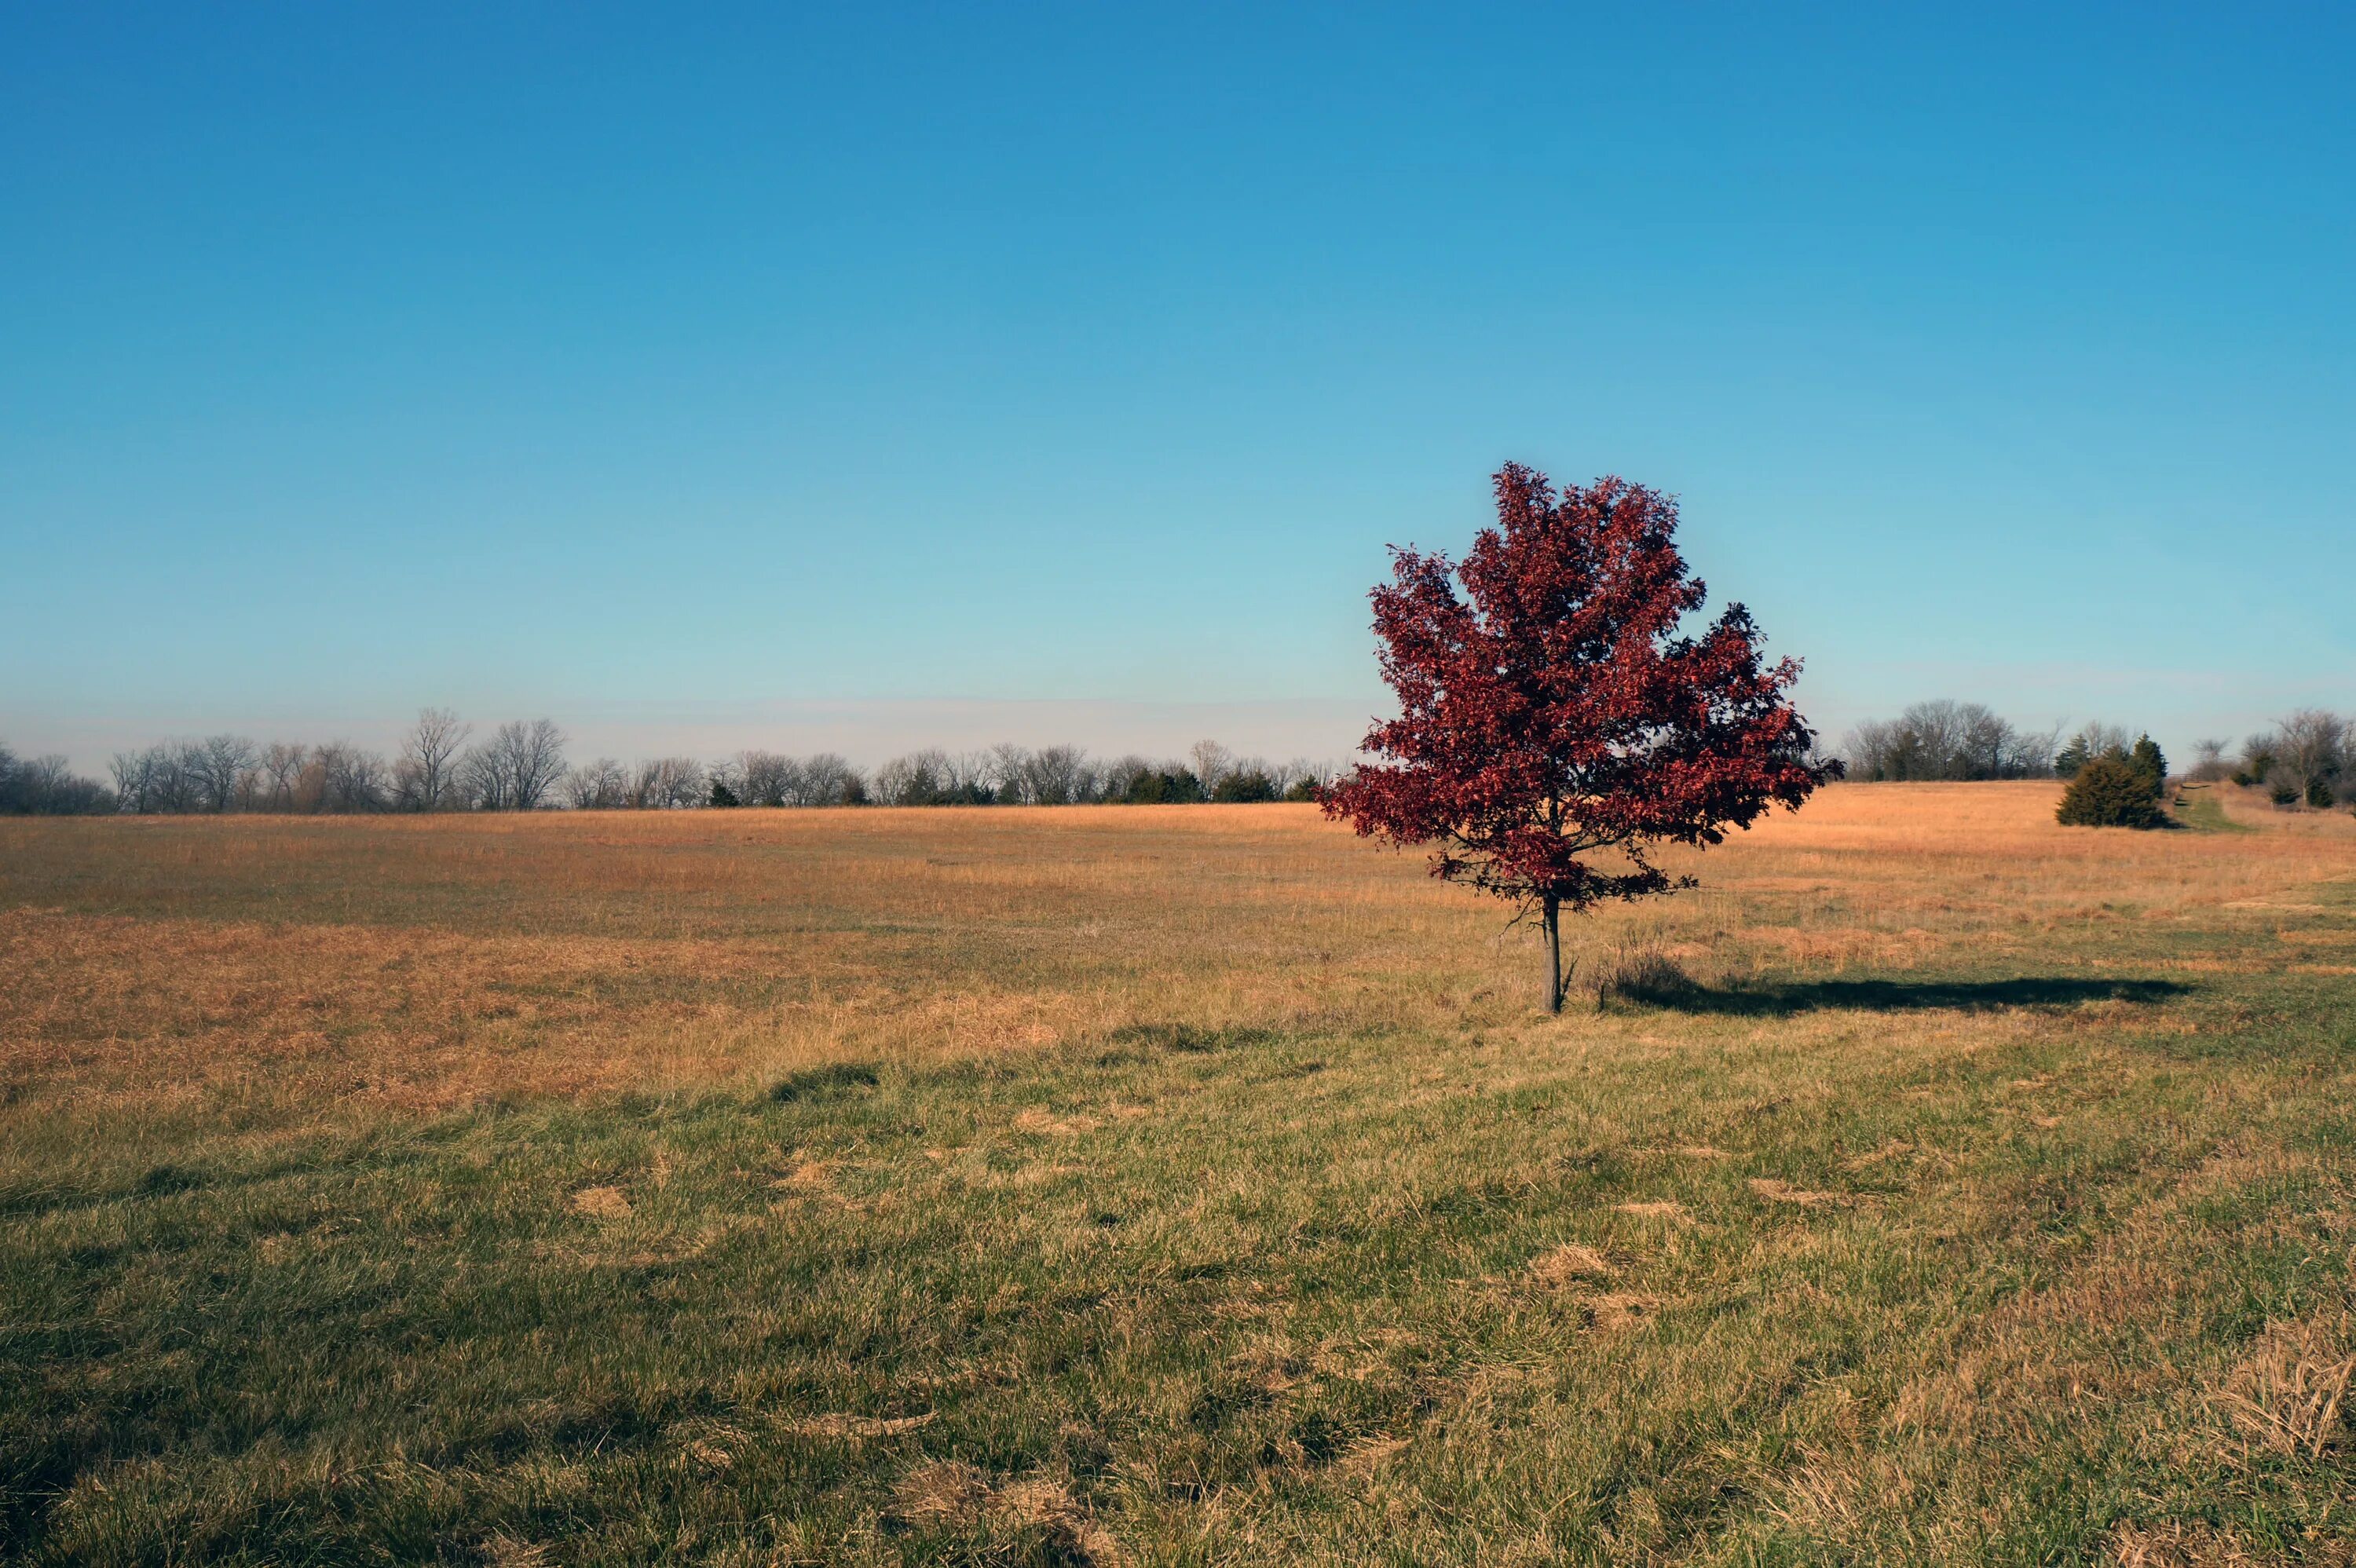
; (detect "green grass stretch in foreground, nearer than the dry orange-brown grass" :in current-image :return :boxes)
[0,951,2356,1563]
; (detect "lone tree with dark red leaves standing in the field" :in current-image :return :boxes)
[1322,464,1840,1012]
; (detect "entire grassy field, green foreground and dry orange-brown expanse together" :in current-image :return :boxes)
[0,784,2356,1566]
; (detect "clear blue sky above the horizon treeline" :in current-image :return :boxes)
[0,5,2356,766]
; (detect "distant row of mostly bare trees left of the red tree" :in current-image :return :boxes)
[0,709,1331,814]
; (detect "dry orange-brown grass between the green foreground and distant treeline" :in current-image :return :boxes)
[0,784,2356,1109]
